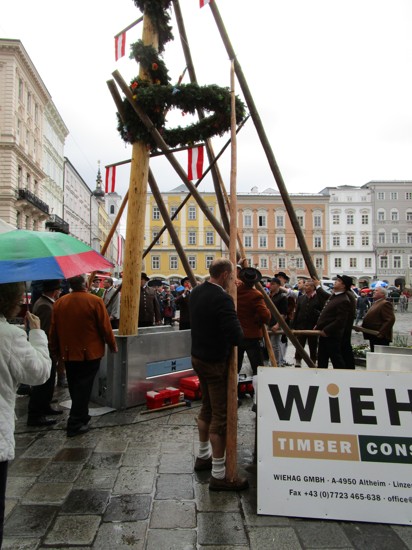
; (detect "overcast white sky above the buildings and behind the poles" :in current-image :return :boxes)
[0,0,412,205]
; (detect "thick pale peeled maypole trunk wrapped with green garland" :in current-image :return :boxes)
[119,14,159,336]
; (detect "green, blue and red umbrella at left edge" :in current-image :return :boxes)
[0,230,113,283]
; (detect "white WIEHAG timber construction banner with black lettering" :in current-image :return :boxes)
[258,367,412,525]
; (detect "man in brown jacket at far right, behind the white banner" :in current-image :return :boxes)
[362,286,396,351]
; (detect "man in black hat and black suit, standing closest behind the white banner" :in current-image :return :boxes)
[315,275,353,369]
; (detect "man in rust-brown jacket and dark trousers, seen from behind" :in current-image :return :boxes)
[49,275,117,437]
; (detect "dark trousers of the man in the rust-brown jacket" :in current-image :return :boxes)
[65,359,100,432]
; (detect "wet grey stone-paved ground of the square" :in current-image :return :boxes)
[3,313,412,550]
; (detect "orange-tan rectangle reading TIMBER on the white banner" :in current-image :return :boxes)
[272,431,359,461]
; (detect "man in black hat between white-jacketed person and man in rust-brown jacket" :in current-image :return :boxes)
[27,280,63,427]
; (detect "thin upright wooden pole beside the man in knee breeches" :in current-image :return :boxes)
[226,62,238,481]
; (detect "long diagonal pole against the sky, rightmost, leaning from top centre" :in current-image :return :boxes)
[209,0,318,279]
